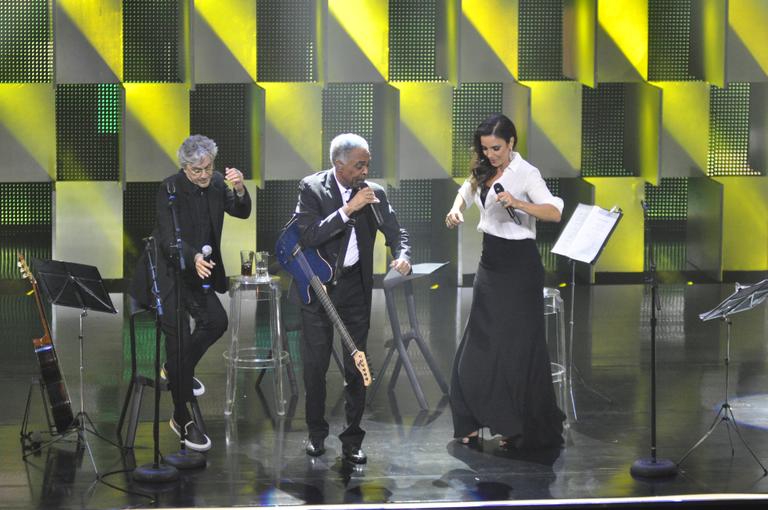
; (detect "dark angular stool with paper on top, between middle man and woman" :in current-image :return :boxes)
[368,262,448,410]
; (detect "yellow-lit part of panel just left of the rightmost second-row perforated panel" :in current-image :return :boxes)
[654,81,709,172]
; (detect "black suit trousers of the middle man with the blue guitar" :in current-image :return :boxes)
[301,266,371,447]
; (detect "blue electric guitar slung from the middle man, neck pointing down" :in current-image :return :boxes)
[275,220,371,386]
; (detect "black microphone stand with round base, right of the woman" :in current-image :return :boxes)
[629,200,677,478]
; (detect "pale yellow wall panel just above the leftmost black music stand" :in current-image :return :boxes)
[53,181,123,279]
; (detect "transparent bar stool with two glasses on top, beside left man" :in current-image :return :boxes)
[224,276,290,416]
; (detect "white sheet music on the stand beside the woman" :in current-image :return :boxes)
[551,204,623,264]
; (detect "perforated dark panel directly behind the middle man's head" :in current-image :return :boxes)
[323,83,382,178]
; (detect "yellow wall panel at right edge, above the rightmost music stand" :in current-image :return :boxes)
[715,177,768,271]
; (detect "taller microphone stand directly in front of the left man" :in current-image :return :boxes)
[162,181,206,469]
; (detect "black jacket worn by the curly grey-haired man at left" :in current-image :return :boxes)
[129,170,251,306]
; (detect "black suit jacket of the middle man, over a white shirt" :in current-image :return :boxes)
[296,169,411,305]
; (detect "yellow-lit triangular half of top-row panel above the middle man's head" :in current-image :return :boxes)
[328,0,389,80]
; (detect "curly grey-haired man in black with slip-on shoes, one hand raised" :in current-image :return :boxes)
[129,135,251,451]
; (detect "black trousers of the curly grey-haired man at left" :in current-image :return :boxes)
[161,282,228,406]
